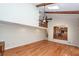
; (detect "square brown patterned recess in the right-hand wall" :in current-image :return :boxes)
[53,26,68,40]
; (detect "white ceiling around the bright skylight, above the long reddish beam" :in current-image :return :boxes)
[35,3,79,12]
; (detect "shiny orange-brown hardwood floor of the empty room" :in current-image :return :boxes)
[4,40,79,56]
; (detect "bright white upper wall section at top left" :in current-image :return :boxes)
[0,3,39,26]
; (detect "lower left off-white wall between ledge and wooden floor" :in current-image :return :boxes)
[0,21,46,49]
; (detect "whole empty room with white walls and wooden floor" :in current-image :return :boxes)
[0,3,79,56]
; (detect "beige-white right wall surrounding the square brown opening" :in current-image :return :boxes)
[48,14,79,46]
